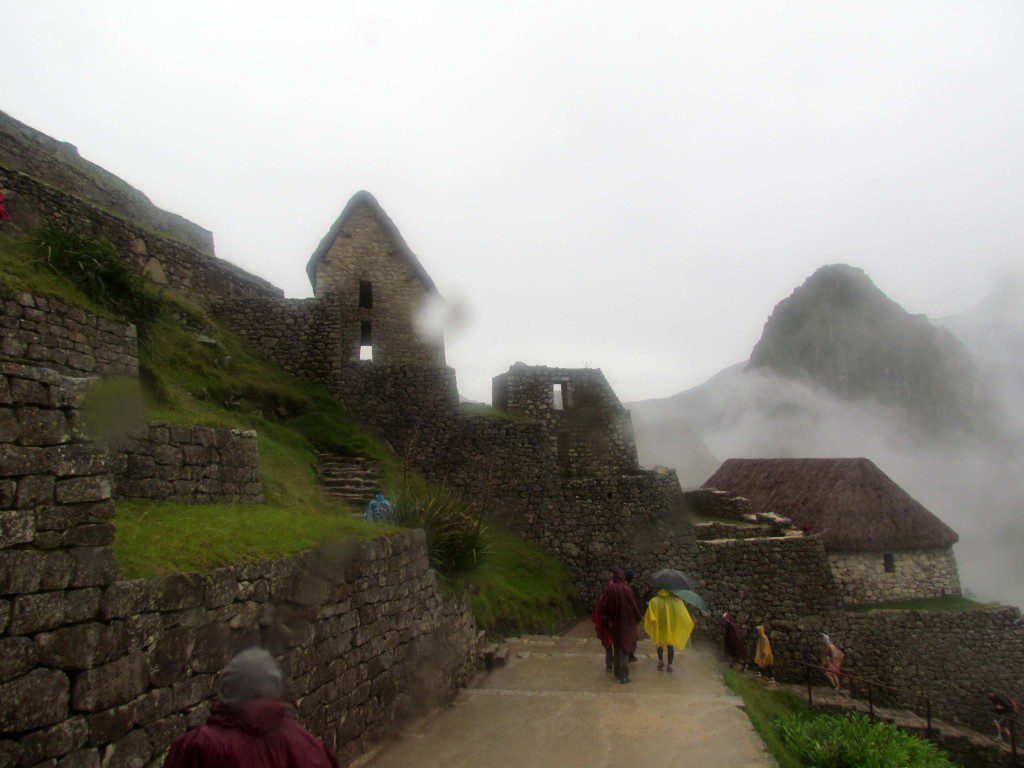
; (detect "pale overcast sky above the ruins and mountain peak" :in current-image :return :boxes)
[0,0,1024,400]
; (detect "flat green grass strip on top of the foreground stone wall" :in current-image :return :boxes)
[114,502,385,579]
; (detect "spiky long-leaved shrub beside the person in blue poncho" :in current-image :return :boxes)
[394,486,490,577]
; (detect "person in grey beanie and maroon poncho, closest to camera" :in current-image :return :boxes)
[164,648,338,768]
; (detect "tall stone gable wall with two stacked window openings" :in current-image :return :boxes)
[315,204,444,367]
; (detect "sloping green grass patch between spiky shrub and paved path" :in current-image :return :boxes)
[463,528,575,635]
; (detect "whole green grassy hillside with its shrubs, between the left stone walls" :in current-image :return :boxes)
[0,225,573,633]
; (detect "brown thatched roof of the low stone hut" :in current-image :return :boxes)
[705,459,959,552]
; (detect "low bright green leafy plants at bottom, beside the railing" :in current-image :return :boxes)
[772,715,953,768]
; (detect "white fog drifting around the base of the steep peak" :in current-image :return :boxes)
[631,280,1024,605]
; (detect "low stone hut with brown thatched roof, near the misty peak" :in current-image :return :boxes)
[705,459,961,604]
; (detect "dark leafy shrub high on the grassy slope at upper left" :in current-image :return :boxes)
[26,223,164,339]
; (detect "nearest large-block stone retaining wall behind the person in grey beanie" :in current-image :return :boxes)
[0,364,476,766]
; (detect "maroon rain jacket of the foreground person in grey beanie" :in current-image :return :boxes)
[164,699,338,768]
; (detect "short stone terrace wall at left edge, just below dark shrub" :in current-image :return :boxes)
[0,288,138,376]
